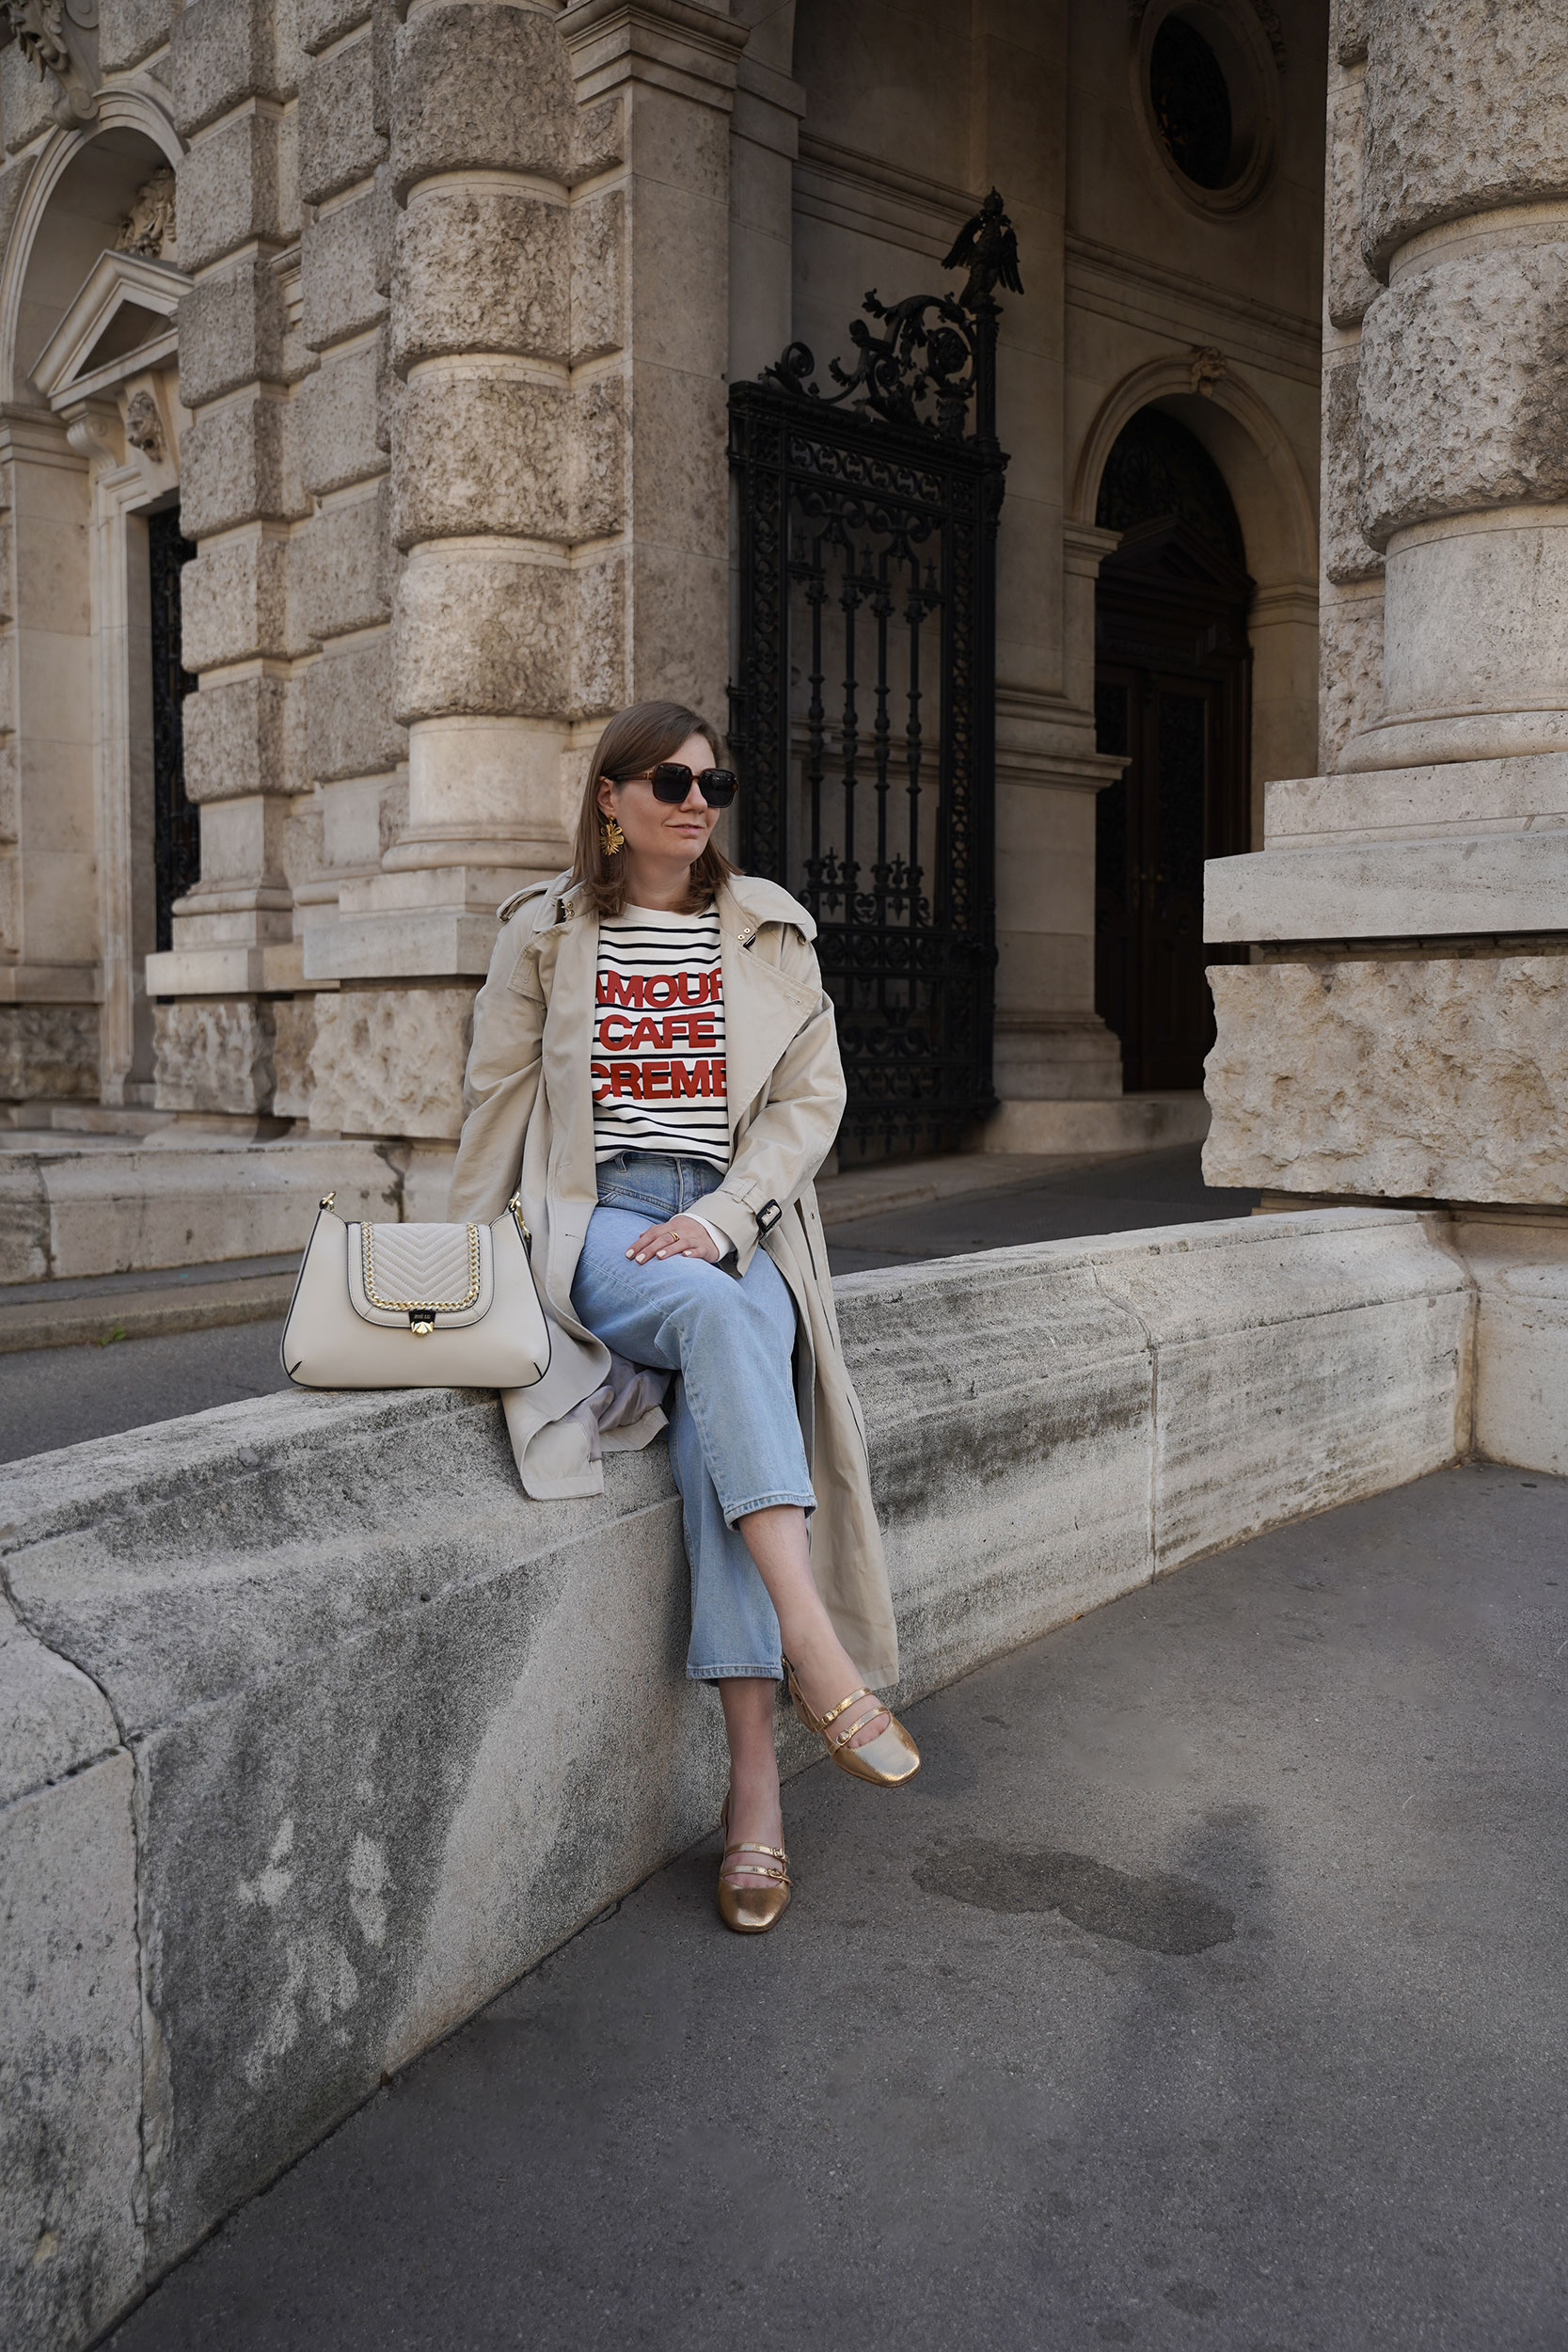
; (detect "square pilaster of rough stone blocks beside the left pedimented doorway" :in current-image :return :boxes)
[146,0,310,1118]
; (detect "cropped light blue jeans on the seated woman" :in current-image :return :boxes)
[571,1152,816,1682]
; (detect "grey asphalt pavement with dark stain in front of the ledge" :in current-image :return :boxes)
[110,1468,1568,2352]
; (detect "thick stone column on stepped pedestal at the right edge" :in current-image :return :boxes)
[1206,0,1568,1470]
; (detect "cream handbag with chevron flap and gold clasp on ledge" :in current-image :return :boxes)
[279,1193,550,1388]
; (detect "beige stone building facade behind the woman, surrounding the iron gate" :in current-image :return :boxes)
[0,0,1325,1184]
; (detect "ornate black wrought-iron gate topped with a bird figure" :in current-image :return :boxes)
[729,191,1022,1157]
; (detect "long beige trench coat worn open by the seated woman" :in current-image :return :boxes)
[447,875,898,1687]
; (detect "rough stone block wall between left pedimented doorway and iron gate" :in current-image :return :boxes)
[137,0,745,1143]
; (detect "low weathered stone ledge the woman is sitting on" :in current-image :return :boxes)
[0,1212,1474,2352]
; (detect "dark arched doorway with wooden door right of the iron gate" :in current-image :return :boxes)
[1096,407,1253,1094]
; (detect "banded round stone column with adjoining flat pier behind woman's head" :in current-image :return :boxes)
[306,0,745,1162]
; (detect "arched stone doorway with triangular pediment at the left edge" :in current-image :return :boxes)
[0,108,195,1108]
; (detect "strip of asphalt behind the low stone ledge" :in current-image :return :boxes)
[0,1143,1258,1461]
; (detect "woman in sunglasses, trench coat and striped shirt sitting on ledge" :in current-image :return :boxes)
[449,704,919,1933]
